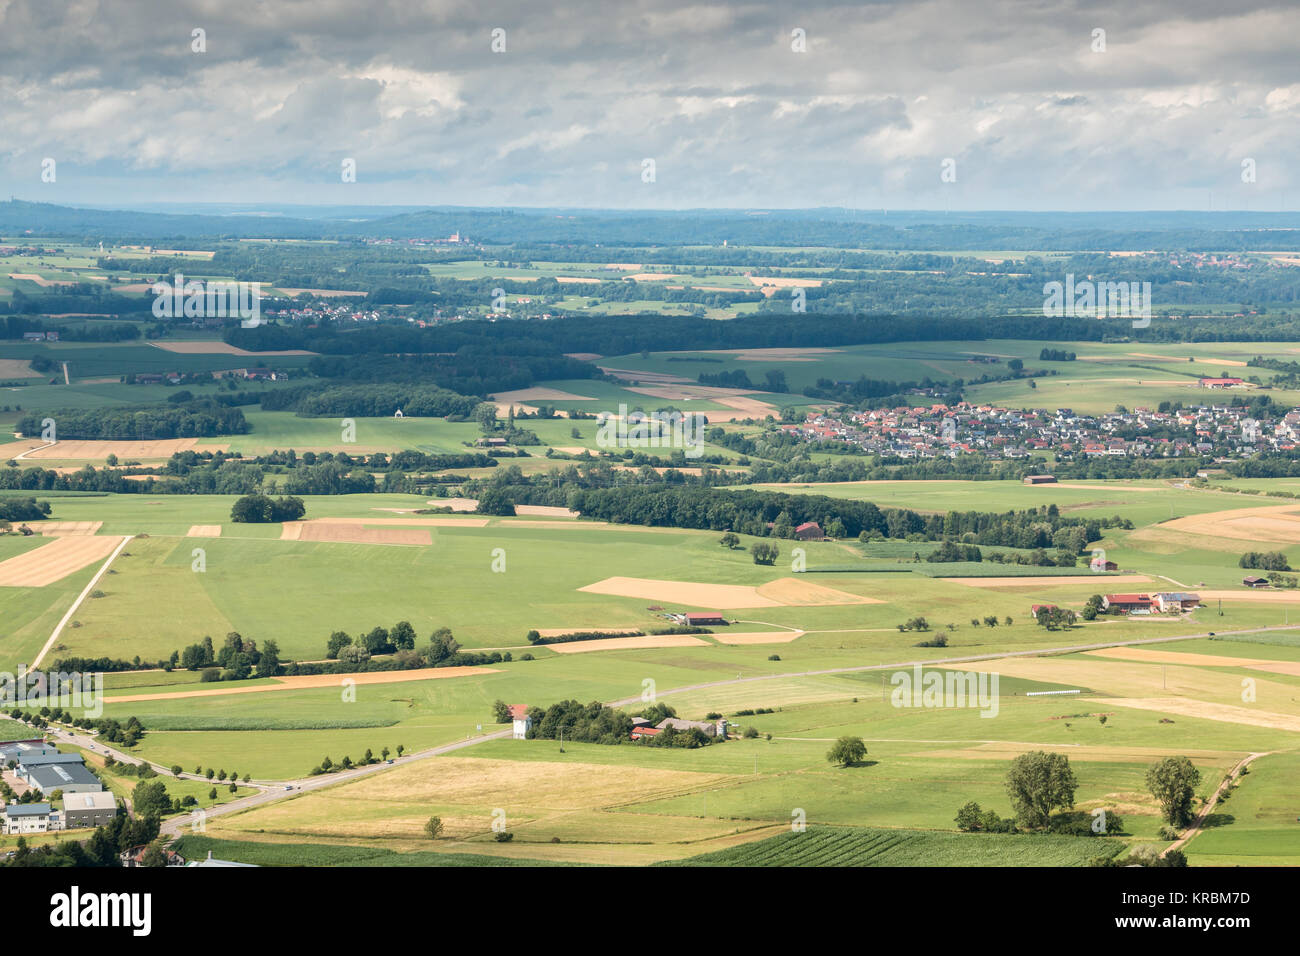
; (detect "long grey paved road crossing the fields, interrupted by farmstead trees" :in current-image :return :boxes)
[139,624,1296,836]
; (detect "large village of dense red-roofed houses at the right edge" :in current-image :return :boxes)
[781,400,1300,460]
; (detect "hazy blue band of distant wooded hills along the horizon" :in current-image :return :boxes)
[0,200,1300,251]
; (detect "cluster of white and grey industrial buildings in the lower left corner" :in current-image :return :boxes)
[0,740,117,834]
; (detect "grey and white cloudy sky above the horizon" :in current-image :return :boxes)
[0,0,1300,211]
